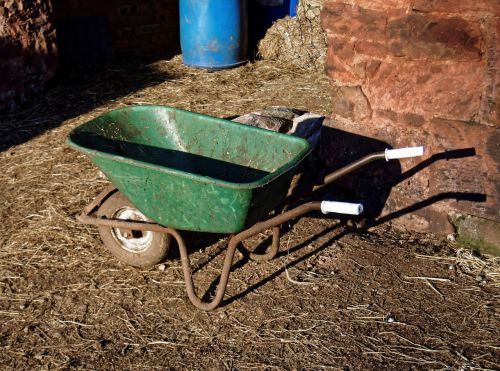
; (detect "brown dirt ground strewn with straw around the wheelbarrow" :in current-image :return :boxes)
[0,57,500,370]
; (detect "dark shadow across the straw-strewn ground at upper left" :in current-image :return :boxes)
[0,54,179,151]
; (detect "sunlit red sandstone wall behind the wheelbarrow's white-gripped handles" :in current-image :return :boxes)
[322,0,500,232]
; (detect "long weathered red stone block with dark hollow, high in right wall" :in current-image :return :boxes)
[323,4,484,61]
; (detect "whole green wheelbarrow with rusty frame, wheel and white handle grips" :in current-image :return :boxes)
[68,106,423,310]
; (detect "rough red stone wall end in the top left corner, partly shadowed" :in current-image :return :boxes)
[0,0,57,112]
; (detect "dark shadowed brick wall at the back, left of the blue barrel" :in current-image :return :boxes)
[52,0,180,61]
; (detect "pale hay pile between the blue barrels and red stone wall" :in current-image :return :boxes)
[259,0,326,71]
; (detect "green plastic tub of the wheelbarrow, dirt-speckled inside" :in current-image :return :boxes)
[68,106,310,233]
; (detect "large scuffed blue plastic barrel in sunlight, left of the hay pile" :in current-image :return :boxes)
[179,0,248,69]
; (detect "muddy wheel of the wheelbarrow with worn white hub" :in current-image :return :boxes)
[97,191,170,268]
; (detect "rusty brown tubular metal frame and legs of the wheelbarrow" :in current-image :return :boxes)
[76,152,385,310]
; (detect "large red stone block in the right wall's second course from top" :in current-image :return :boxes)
[363,62,484,121]
